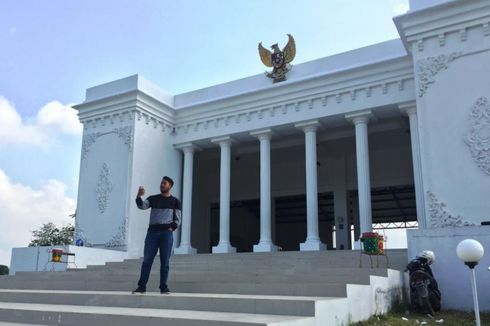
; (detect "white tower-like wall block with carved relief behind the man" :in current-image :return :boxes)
[75,75,182,257]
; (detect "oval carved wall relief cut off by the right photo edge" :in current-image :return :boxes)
[464,96,490,175]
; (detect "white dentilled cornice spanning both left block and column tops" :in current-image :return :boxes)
[74,54,415,143]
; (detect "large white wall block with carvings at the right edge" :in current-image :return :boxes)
[395,1,490,227]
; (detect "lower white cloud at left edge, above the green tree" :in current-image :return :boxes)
[0,169,76,265]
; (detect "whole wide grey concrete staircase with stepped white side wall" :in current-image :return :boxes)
[0,250,407,325]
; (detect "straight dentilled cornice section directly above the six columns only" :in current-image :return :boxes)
[171,56,415,142]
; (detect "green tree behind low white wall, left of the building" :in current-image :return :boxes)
[29,222,75,247]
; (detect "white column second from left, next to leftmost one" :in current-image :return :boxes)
[211,136,236,253]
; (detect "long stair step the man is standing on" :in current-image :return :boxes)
[0,290,343,317]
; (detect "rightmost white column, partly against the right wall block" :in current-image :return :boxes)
[398,102,427,229]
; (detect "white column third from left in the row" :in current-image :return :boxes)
[250,129,277,252]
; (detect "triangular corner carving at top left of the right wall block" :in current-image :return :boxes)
[417,52,462,97]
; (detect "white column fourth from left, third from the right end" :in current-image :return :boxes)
[295,120,327,251]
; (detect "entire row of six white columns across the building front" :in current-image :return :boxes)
[175,103,425,254]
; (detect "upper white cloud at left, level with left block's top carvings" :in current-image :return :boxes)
[0,96,83,148]
